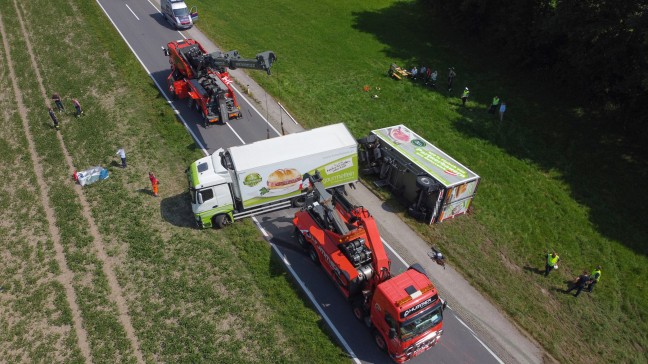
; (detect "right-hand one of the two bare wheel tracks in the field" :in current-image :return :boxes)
[12,0,144,363]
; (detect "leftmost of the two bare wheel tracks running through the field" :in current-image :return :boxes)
[0,10,92,363]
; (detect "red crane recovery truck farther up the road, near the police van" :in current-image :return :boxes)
[164,39,277,127]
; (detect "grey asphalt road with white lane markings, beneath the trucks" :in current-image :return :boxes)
[97,0,501,363]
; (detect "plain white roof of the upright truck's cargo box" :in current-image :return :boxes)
[229,123,357,171]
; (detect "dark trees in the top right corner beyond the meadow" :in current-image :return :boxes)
[422,0,648,136]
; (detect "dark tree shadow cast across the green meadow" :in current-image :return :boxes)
[353,2,648,255]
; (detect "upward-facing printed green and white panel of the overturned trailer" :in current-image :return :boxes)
[372,125,479,187]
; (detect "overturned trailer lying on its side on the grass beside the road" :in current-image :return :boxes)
[358,125,480,224]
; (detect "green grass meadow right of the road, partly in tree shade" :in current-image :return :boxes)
[193,0,648,363]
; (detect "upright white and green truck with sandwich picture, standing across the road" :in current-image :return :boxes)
[187,123,358,228]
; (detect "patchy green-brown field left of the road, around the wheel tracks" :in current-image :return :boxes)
[0,0,346,363]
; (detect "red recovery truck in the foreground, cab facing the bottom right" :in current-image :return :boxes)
[293,174,445,363]
